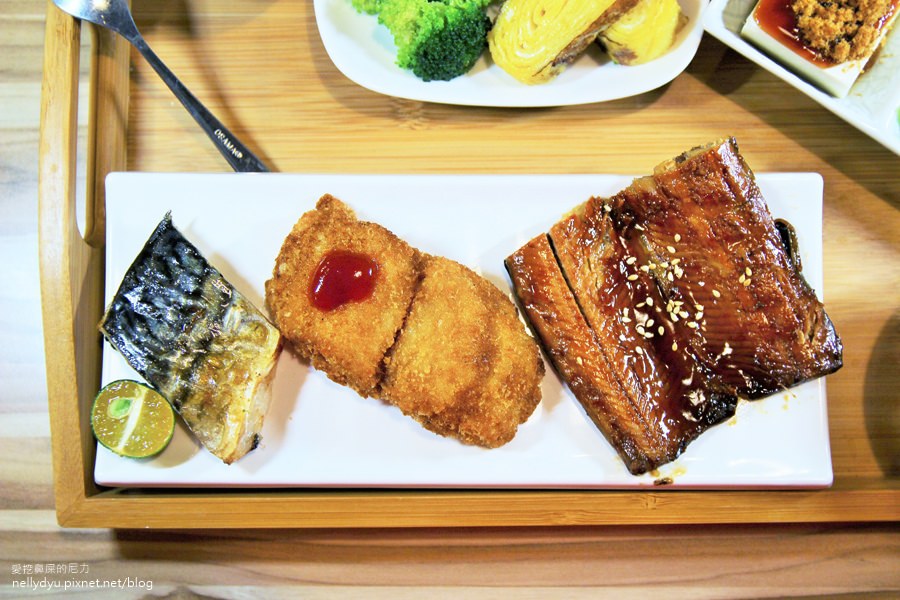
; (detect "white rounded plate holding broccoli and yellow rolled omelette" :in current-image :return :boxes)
[315,0,707,107]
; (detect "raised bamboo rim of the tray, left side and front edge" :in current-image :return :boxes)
[39,2,900,528]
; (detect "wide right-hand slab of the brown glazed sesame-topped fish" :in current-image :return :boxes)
[611,140,842,398]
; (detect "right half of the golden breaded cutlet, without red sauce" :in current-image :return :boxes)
[381,256,544,448]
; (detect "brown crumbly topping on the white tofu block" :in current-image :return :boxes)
[791,0,894,63]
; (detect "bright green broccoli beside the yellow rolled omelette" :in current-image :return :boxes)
[353,0,493,81]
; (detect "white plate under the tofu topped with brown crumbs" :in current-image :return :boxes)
[703,0,900,154]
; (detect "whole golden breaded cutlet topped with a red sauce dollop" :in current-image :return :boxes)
[266,195,544,448]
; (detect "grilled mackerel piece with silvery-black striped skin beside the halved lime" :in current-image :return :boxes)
[100,214,281,464]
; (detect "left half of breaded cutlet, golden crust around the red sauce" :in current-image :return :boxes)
[266,195,419,396]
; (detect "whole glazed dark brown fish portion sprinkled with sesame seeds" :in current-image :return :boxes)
[506,139,842,474]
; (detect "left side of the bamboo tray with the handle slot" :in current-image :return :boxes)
[38,1,128,516]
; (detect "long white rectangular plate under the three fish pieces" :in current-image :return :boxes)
[95,173,832,488]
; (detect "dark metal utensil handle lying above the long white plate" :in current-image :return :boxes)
[126,31,269,173]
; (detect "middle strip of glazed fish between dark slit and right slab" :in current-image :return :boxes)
[550,204,737,468]
